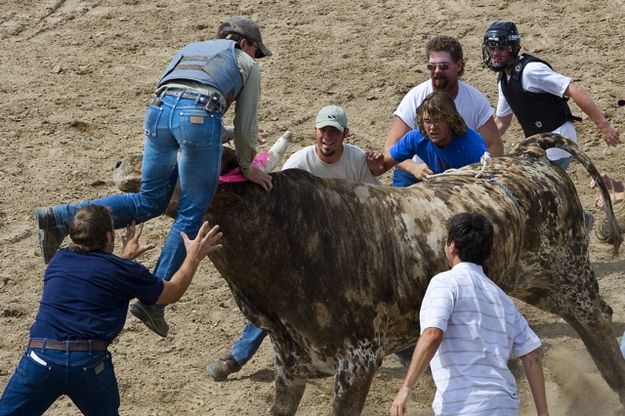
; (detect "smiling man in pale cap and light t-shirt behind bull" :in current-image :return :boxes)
[206,105,381,381]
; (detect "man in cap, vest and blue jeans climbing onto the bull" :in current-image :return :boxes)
[35,16,272,337]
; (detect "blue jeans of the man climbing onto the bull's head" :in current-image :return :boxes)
[53,96,222,280]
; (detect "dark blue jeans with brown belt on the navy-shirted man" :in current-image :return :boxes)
[0,348,119,416]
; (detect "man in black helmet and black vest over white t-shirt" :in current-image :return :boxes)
[482,20,619,169]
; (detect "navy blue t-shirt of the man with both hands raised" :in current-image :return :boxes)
[30,249,163,341]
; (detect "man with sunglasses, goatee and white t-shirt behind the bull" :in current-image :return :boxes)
[385,36,503,187]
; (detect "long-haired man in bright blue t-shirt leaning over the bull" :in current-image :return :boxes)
[374,92,488,180]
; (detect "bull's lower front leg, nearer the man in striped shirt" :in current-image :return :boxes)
[332,351,381,416]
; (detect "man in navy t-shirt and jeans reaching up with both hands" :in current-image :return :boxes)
[0,205,221,416]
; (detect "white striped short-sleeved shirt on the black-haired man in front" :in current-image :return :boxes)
[420,263,541,416]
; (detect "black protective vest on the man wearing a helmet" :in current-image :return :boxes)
[499,54,581,137]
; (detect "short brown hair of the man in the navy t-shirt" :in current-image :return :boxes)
[69,205,115,252]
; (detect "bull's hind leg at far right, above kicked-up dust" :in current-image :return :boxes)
[520,266,625,406]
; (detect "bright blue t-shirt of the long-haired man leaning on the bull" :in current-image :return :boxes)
[389,129,488,187]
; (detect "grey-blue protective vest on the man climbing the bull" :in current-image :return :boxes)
[158,39,243,108]
